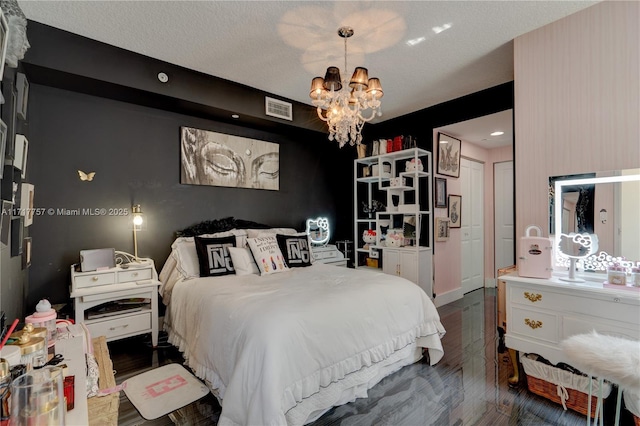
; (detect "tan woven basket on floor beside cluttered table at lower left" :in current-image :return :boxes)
[87,336,120,426]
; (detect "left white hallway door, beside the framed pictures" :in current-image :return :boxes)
[460,158,484,293]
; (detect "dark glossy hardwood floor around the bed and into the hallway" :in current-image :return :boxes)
[109,289,624,426]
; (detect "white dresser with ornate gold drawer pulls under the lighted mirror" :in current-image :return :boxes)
[500,273,640,380]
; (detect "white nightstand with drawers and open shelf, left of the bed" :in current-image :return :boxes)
[70,259,160,347]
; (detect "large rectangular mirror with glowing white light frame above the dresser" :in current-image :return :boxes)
[549,169,640,272]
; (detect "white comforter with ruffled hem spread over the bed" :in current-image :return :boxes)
[165,263,444,425]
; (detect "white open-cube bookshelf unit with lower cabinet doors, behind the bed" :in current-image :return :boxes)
[354,148,433,297]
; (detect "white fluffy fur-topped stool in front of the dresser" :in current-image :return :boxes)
[560,331,640,426]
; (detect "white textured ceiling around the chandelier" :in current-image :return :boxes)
[19,0,596,145]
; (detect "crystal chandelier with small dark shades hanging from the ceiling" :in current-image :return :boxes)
[309,27,383,148]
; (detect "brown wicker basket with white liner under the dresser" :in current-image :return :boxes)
[521,355,608,420]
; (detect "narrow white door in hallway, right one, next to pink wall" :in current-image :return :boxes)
[493,161,516,277]
